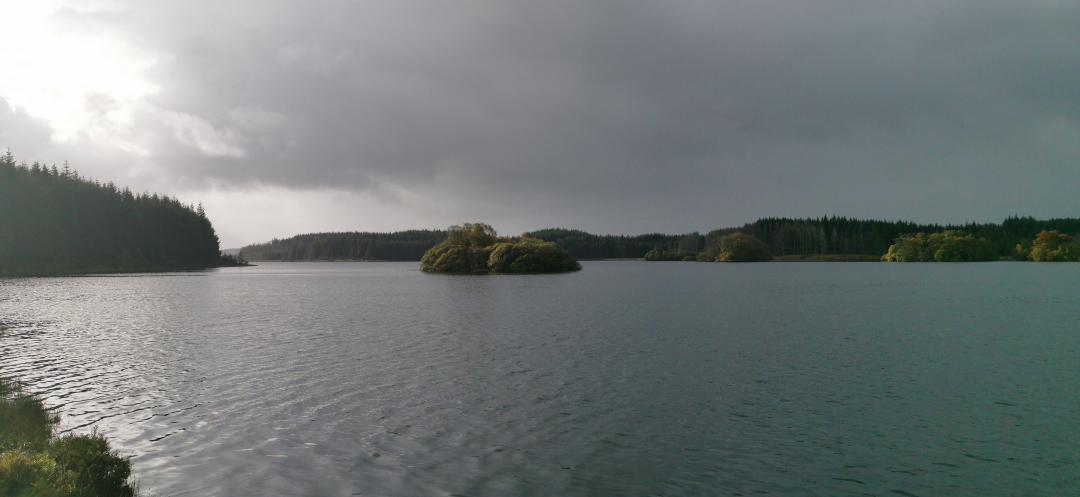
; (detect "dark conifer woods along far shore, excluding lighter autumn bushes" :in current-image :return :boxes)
[242,216,1080,261]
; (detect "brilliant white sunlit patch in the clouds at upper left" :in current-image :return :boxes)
[0,0,157,145]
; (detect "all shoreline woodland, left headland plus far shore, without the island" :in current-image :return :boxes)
[0,152,1080,277]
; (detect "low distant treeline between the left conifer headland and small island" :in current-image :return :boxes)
[240,230,446,260]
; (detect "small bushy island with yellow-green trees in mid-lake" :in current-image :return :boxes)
[420,223,581,274]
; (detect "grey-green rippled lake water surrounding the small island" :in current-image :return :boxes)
[0,261,1080,497]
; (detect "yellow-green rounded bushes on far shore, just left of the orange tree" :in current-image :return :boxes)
[881,230,998,263]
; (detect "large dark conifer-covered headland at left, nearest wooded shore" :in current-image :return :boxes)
[0,152,235,276]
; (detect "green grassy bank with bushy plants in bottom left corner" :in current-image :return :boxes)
[0,378,135,497]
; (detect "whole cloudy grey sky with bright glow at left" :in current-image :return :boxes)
[0,0,1080,247]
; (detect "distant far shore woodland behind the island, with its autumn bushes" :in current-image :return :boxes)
[240,216,1080,261]
